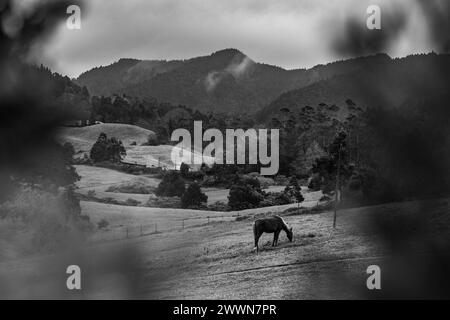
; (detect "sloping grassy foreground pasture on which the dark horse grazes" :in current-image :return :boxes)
[0,200,450,299]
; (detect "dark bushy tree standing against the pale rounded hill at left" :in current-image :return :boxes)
[90,133,127,162]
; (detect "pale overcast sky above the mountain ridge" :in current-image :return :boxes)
[38,0,436,77]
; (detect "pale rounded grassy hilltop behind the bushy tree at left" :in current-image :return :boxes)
[59,123,155,153]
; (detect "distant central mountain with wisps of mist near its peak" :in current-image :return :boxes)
[76,49,390,114]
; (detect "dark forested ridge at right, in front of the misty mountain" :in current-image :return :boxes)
[257,53,450,122]
